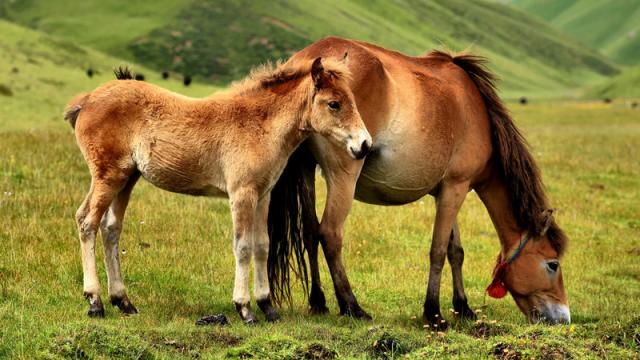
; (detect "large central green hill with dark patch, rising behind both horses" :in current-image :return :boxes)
[0,0,617,97]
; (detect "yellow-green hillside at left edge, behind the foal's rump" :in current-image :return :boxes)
[0,20,215,131]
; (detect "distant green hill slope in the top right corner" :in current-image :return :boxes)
[513,0,640,65]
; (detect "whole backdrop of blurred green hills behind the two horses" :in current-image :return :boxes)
[0,0,640,98]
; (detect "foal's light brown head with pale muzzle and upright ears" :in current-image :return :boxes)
[306,58,372,159]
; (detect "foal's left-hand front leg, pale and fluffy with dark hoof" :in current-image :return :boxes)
[229,188,258,324]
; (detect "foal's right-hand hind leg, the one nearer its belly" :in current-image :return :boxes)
[100,173,140,314]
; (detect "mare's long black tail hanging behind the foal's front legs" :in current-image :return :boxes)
[268,144,318,305]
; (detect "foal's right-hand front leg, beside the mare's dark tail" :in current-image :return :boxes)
[253,194,280,322]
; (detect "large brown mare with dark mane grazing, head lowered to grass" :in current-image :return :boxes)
[270,37,570,328]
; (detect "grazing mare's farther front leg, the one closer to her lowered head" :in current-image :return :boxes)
[447,220,476,320]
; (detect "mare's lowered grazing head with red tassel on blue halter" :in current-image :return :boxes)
[487,214,571,324]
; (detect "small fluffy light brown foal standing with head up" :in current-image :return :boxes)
[65,57,371,323]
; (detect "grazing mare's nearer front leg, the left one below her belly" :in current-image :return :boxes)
[423,183,469,330]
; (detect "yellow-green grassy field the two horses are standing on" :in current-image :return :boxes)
[0,76,640,359]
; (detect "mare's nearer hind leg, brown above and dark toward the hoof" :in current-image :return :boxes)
[310,155,371,320]
